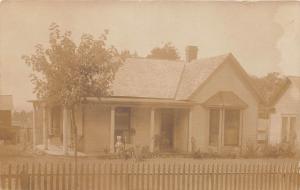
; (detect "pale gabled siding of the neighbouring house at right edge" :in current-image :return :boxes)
[269,83,300,149]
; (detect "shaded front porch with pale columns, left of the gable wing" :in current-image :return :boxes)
[33,99,191,155]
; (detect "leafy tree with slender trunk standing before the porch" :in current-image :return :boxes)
[23,23,122,188]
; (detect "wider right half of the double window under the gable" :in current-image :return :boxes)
[224,110,240,146]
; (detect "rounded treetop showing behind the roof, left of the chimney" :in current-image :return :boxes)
[147,42,180,60]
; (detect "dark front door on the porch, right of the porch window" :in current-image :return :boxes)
[160,109,174,151]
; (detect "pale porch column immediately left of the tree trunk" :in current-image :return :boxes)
[63,107,71,155]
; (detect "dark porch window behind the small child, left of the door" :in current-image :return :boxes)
[115,107,131,144]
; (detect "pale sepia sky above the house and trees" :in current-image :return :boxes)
[0,0,300,110]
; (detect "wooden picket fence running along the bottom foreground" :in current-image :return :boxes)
[0,161,300,190]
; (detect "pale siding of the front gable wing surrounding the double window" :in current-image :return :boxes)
[191,61,258,151]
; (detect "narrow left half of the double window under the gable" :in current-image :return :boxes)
[209,109,220,146]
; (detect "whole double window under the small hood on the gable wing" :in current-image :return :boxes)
[209,109,241,146]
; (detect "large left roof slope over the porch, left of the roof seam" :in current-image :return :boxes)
[112,58,184,99]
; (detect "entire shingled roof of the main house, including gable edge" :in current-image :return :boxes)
[112,53,262,100]
